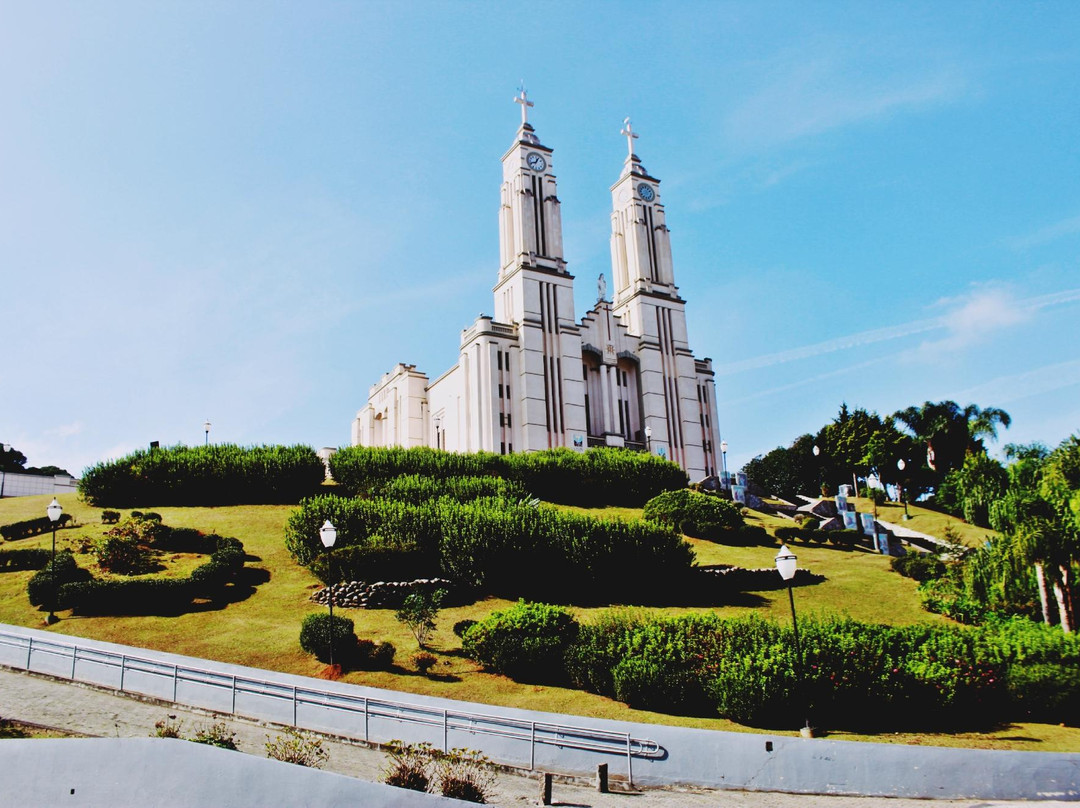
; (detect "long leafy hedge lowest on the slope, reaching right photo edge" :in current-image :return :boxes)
[463,603,1080,730]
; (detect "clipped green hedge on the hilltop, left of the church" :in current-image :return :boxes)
[79,444,325,508]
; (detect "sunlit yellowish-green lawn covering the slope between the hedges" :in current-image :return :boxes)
[0,495,1080,751]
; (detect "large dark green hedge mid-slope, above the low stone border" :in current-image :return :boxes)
[285,496,693,602]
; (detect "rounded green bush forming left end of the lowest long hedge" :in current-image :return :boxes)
[461,601,578,684]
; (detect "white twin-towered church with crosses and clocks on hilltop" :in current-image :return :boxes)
[352,91,720,480]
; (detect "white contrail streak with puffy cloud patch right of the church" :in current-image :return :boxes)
[714,288,1080,376]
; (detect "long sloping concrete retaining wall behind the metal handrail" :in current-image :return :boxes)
[0,623,1080,800]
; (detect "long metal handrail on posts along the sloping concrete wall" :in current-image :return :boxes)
[0,631,663,783]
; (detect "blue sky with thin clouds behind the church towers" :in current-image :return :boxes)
[0,0,1080,474]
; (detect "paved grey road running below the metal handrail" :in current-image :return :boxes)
[0,668,1076,808]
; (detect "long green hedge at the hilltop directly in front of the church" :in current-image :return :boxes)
[330,446,687,507]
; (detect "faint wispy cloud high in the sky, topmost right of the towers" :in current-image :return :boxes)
[724,55,968,148]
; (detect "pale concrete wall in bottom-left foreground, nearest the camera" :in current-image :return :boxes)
[0,738,469,808]
